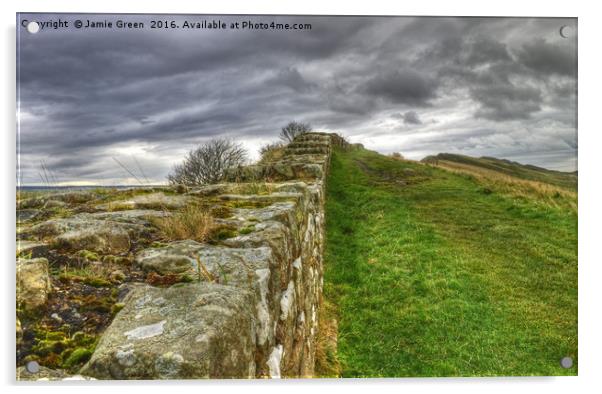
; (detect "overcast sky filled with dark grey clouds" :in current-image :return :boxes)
[17,14,577,185]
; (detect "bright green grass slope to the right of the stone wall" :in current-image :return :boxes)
[324,150,577,377]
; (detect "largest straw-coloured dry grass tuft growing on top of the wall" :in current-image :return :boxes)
[151,204,215,242]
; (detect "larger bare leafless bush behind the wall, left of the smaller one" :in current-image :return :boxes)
[167,138,247,186]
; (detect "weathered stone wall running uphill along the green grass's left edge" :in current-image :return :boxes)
[75,133,343,379]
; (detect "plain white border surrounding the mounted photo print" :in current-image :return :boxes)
[0,0,602,394]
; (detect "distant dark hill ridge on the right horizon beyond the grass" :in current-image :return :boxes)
[422,153,577,190]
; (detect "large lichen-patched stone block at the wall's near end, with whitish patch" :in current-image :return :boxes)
[80,283,256,379]
